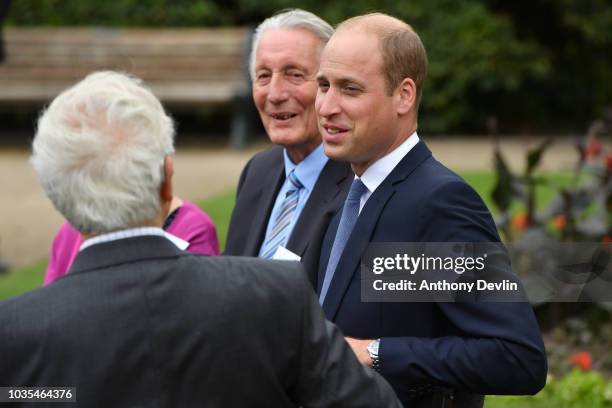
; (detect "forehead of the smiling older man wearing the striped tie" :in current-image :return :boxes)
[255,28,323,71]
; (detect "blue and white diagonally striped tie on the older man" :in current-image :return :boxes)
[261,171,304,259]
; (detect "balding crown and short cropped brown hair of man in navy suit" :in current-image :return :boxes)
[336,13,427,108]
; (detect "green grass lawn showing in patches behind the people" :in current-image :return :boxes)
[0,171,570,300]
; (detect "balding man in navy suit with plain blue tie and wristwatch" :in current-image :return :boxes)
[316,13,547,406]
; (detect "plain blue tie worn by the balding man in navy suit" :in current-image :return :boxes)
[319,178,368,304]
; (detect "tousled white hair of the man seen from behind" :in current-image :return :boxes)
[30,71,174,234]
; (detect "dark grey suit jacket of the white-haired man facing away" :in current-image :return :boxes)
[0,236,399,408]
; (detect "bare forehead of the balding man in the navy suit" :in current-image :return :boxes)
[320,30,382,76]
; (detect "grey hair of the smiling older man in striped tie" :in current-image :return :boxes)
[249,9,334,80]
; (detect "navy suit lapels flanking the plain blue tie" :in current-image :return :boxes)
[319,141,431,321]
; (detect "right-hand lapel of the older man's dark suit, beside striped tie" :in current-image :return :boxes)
[287,160,351,256]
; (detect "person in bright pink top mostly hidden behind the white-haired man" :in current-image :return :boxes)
[43,197,219,286]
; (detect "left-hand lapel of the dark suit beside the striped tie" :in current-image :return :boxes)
[245,155,285,256]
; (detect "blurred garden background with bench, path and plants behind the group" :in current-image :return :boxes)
[0,0,612,407]
